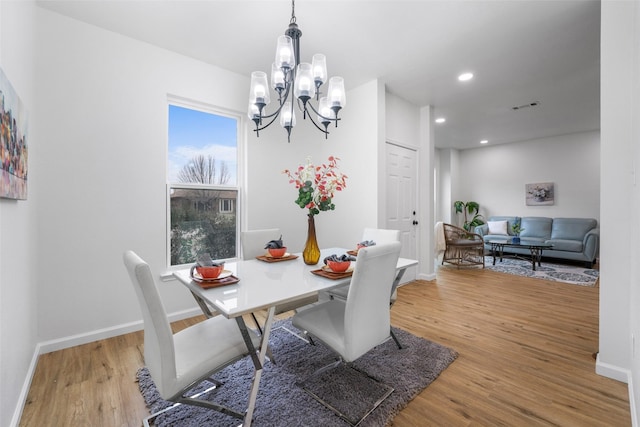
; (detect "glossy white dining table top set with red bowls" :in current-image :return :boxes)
[173,248,418,318]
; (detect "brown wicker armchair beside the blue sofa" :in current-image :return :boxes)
[442,224,484,268]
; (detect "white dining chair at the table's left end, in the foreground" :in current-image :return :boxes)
[123,251,262,426]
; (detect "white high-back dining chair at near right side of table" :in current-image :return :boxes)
[292,242,401,424]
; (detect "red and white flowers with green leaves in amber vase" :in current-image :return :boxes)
[282,156,347,216]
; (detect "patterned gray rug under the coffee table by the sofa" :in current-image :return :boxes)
[485,256,599,286]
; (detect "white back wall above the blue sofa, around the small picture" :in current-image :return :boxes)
[452,132,600,219]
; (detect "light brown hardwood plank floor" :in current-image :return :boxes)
[20,268,631,427]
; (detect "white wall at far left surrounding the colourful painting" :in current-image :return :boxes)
[0,1,37,426]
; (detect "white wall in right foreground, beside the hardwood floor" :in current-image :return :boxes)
[596,1,640,416]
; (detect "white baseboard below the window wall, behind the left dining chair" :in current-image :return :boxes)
[38,308,202,354]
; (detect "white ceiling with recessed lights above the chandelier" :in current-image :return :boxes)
[37,0,600,149]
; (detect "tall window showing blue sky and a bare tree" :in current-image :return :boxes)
[167,101,240,266]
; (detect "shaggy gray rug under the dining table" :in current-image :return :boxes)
[137,319,458,427]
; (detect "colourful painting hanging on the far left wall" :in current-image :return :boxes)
[0,69,28,200]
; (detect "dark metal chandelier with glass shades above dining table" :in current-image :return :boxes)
[248,0,347,142]
